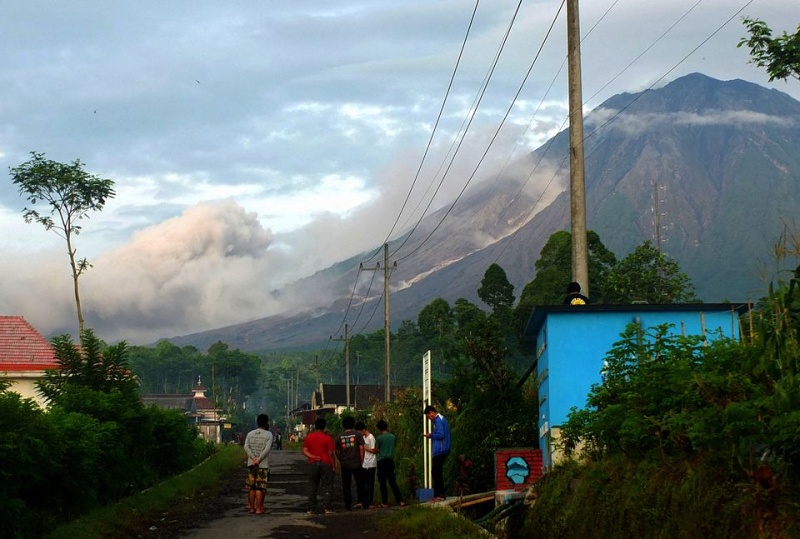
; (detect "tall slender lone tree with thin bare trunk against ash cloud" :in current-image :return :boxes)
[10,152,116,334]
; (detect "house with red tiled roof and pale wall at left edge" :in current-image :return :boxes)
[0,316,58,407]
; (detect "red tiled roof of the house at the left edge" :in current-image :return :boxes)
[0,316,58,372]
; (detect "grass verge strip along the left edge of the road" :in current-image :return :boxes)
[43,445,244,539]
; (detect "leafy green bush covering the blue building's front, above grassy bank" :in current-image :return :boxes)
[562,324,764,465]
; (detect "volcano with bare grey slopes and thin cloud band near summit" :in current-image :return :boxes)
[170,74,800,350]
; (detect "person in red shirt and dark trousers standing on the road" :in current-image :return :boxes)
[303,417,334,515]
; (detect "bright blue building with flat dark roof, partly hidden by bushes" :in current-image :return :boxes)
[525,303,748,470]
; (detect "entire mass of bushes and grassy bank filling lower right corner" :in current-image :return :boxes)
[526,306,800,537]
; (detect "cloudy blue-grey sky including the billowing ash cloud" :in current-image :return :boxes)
[0,0,800,344]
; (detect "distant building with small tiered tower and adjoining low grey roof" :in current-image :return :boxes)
[142,377,225,443]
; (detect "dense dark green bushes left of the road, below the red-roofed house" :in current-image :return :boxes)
[0,330,213,537]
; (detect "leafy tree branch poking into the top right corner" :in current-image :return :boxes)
[736,18,800,82]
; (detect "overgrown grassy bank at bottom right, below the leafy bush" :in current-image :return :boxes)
[512,457,764,539]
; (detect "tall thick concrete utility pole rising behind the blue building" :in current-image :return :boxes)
[567,0,589,296]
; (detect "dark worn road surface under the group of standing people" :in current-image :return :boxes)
[171,451,393,539]
